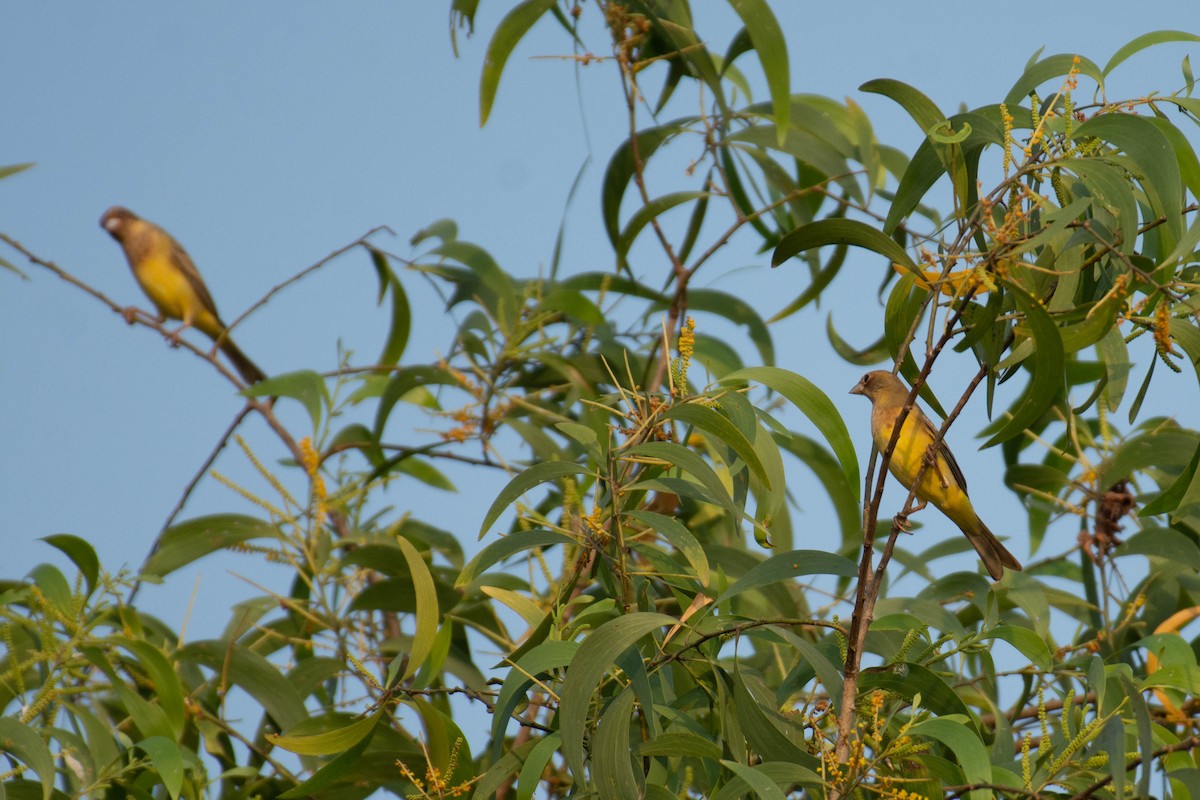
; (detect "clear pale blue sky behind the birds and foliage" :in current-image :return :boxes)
[0,0,1200,634]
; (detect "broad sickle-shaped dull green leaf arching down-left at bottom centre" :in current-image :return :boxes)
[558,612,679,781]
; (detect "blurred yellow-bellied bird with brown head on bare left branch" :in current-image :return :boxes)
[100,205,266,384]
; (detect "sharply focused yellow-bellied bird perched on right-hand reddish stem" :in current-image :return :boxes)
[850,369,1021,581]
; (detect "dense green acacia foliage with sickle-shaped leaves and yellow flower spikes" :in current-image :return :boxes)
[0,6,1200,800]
